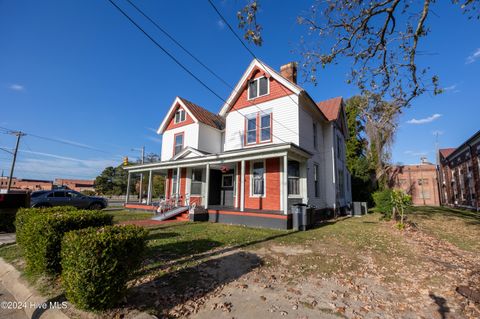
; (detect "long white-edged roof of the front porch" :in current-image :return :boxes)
[123,143,312,172]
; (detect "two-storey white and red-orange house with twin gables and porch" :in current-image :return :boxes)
[125,59,351,228]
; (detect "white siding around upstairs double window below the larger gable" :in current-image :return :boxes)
[225,95,299,151]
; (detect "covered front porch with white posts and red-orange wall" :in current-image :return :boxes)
[125,144,310,229]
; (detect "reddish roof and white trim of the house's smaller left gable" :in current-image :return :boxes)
[157,96,225,134]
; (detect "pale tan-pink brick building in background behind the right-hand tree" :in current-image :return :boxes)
[390,159,440,206]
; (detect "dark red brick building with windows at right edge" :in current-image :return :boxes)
[438,131,480,210]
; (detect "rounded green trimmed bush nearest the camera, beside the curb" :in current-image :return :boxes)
[61,225,148,310]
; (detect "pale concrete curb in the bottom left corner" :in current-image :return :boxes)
[0,257,69,319]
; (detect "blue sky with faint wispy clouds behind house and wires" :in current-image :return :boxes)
[0,0,480,179]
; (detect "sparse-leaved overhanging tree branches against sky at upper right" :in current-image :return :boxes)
[237,0,480,108]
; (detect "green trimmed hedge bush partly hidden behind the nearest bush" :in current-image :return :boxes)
[17,207,113,275]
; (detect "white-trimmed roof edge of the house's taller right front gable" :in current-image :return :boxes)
[219,59,305,116]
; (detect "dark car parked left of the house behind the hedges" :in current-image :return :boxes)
[30,189,108,210]
